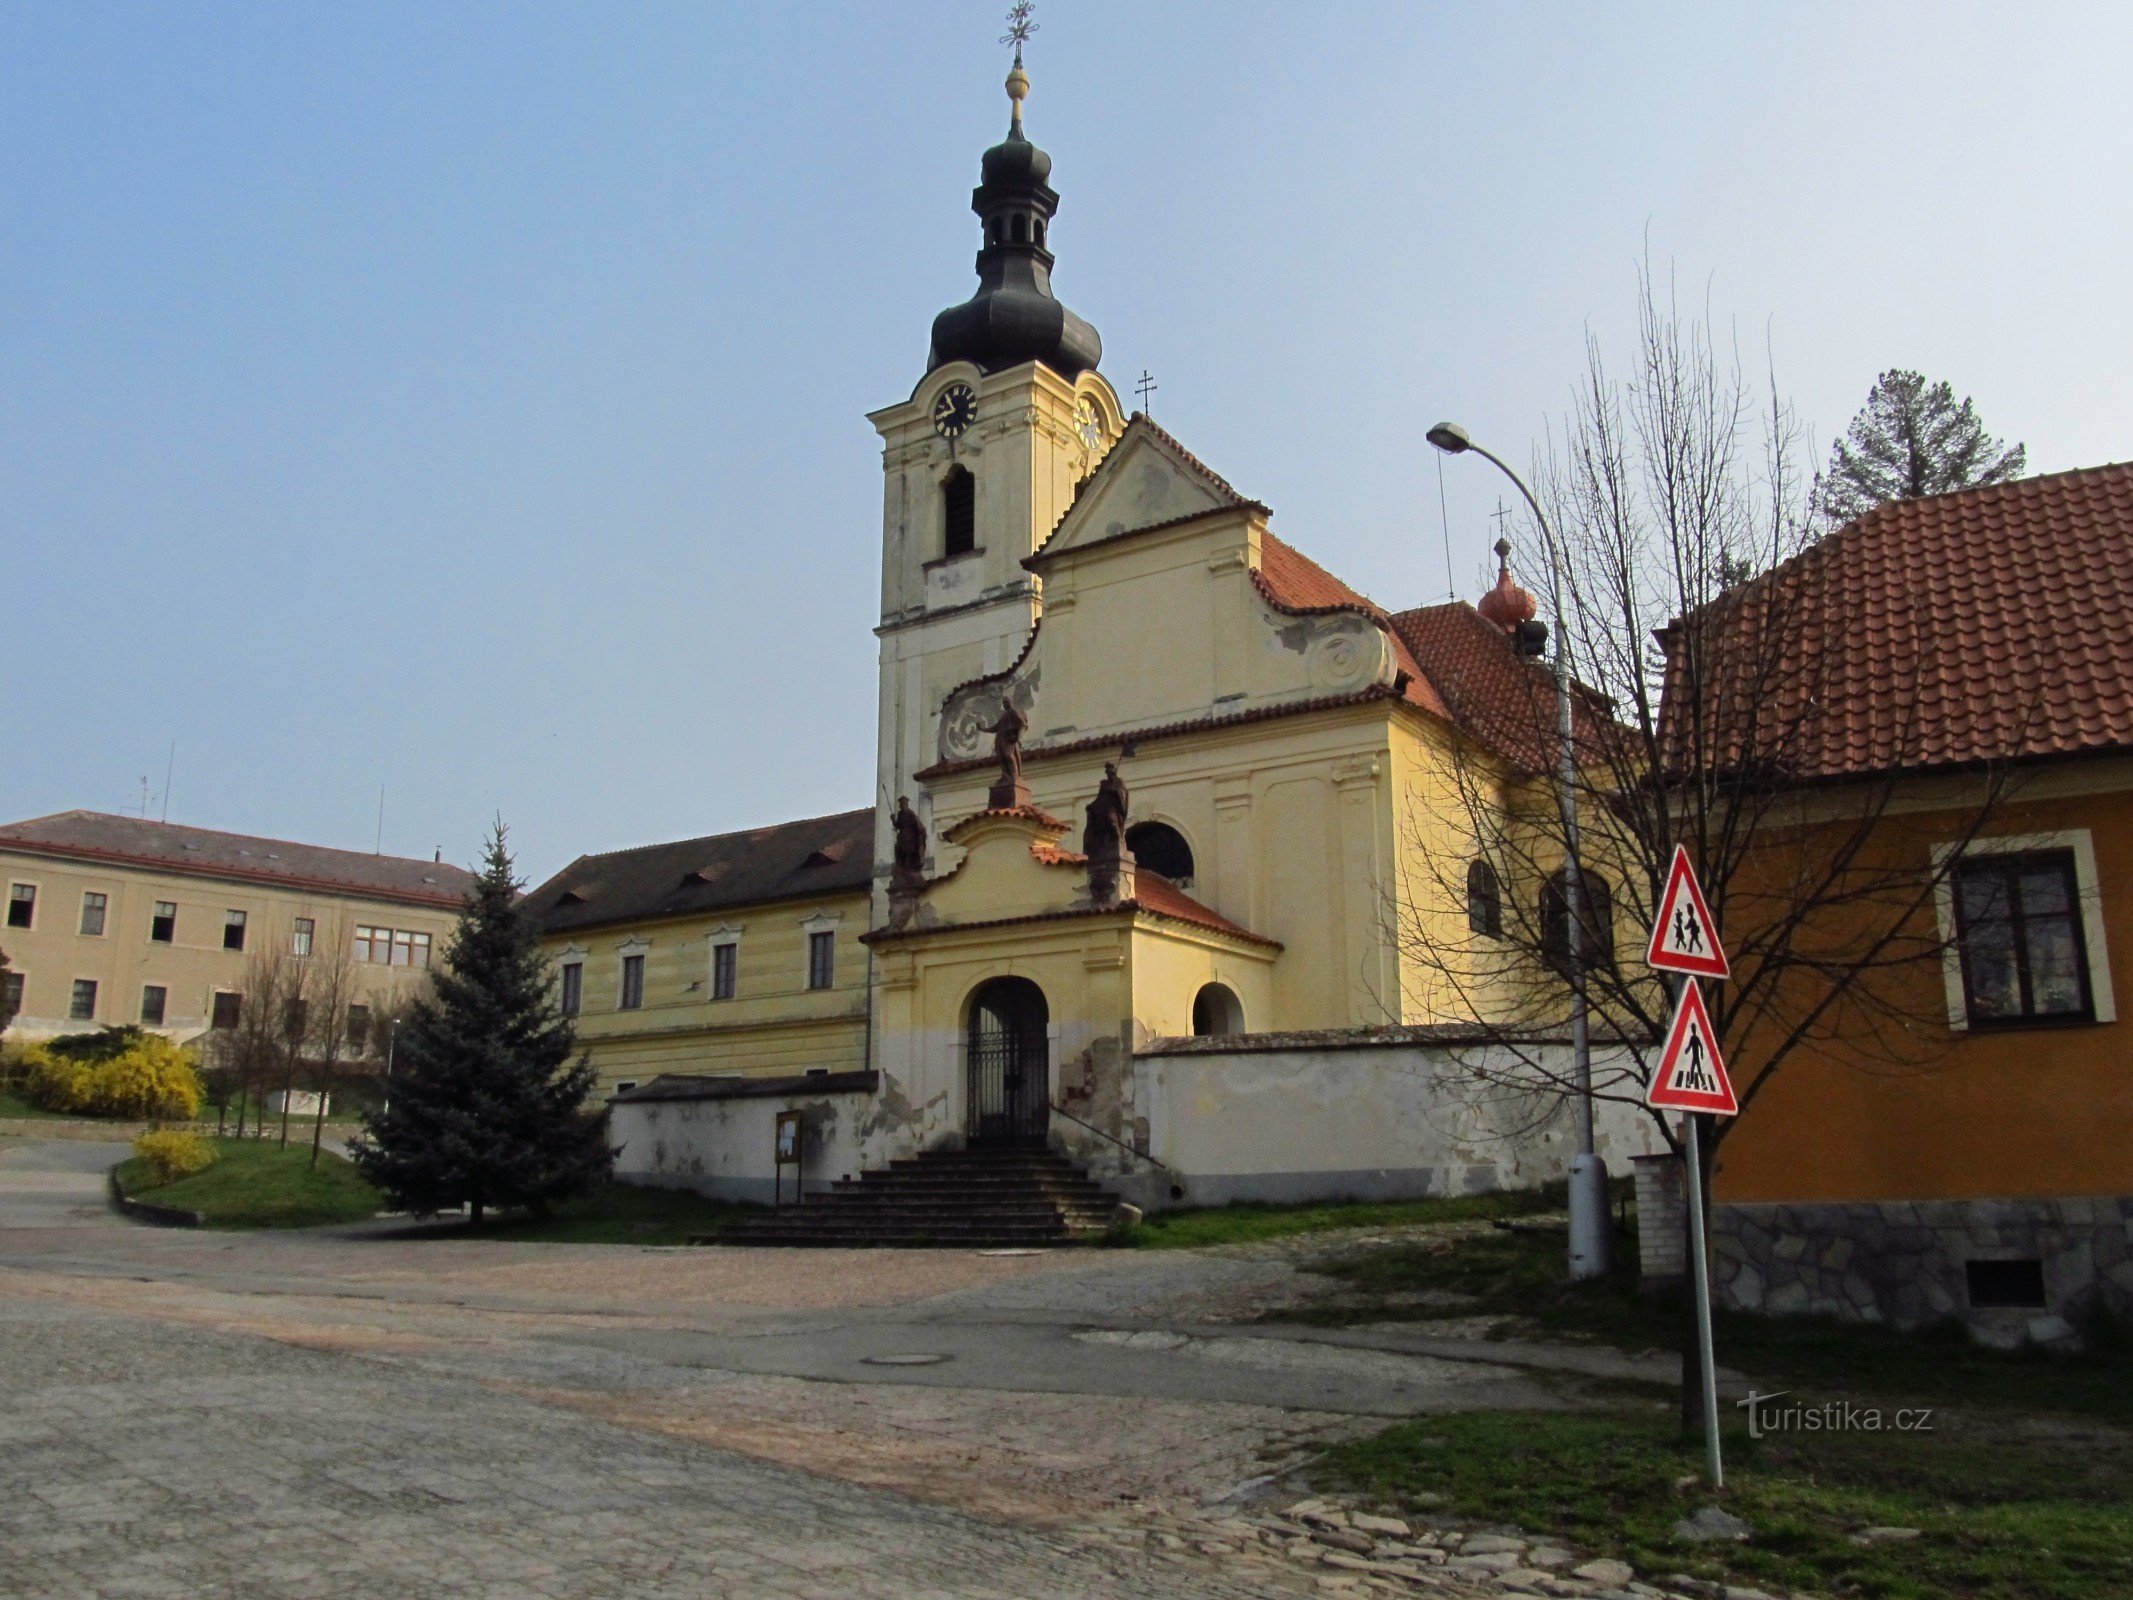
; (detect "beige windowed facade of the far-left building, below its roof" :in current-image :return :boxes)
[0,849,459,1041]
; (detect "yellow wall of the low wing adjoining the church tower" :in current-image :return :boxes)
[542,892,868,1090]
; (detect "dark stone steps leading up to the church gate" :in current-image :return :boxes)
[704,1146,1118,1248]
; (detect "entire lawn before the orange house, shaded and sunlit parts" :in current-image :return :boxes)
[1308,1225,2133,1600]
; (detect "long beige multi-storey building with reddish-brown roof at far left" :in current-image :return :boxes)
[0,811,474,1041]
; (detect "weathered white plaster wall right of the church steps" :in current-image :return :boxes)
[1103,1045,1659,1207]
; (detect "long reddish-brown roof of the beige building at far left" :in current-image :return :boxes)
[0,811,474,907]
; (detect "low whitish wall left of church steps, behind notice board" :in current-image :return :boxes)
[608,1090,875,1205]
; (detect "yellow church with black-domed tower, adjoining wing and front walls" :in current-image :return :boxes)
[527,53,1649,1242]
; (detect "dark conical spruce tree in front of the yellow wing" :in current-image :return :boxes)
[348,821,610,1222]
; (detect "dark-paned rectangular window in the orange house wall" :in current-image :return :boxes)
[1954,849,2092,1028]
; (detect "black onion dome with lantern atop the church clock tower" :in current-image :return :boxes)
[926,53,1103,378]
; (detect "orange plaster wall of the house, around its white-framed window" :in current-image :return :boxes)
[1713,762,2133,1203]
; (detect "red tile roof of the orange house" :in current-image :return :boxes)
[1664,463,2133,779]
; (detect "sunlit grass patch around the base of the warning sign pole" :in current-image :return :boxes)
[1320,1404,2133,1600]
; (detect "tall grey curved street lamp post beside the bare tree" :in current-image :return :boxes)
[1427,422,1610,1278]
